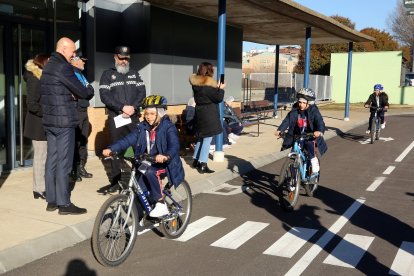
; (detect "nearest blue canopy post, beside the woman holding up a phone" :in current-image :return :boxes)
[213,0,226,162]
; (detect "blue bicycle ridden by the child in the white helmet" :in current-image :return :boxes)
[278,133,320,211]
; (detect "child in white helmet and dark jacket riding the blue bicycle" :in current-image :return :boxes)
[275,88,328,173]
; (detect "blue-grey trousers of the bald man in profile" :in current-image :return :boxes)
[45,127,75,206]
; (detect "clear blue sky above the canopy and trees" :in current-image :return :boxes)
[243,0,402,51]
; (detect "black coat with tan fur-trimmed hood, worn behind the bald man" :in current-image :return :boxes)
[23,59,46,141]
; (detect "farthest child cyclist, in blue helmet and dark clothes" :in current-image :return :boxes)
[364,84,389,134]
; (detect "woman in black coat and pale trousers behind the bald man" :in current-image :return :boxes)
[23,54,49,199]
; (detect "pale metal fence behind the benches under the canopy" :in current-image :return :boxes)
[242,73,332,104]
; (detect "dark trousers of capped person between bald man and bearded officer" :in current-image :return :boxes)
[73,111,90,166]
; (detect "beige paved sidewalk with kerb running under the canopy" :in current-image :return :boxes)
[0,107,414,274]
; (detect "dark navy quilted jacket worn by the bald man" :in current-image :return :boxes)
[40,52,93,128]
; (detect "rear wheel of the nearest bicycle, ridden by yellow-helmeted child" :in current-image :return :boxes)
[160,180,193,239]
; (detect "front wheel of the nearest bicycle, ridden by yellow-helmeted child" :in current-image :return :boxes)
[92,194,138,266]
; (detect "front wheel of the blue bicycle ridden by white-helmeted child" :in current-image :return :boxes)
[279,158,300,211]
